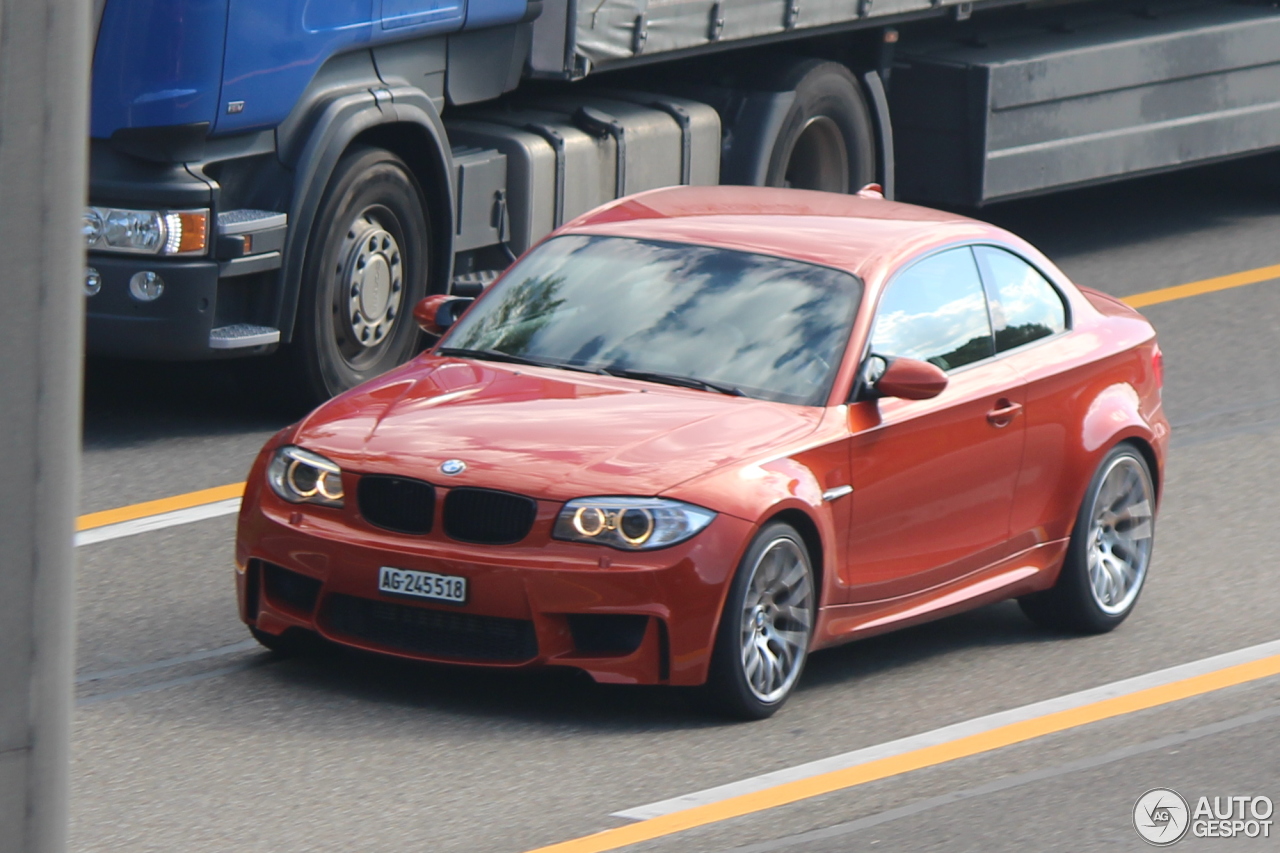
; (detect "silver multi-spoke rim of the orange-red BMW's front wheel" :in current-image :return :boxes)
[741,537,813,703]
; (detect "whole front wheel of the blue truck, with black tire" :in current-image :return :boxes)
[285,147,430,405]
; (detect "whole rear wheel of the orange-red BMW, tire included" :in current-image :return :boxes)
[1018,444,1156,634]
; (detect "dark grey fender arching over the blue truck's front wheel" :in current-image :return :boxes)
[276,90,453,342]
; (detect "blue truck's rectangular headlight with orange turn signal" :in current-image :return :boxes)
[82,207,209,255]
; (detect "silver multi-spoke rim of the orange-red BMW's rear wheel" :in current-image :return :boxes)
[1085,455,1153,616]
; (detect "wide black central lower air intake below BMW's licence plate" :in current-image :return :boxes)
[324,594,538,663]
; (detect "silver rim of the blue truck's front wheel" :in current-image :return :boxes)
[338,209,404,352]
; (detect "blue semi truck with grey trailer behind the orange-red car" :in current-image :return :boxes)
[83,0,1280,403]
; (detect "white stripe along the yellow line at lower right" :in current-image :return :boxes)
[612,640,1280,821]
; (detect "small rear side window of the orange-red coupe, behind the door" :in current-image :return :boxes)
[974,246,1066,352]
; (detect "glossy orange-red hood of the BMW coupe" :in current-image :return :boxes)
[293,356,822,501]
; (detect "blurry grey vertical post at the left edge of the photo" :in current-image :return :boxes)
[0,0,90,853]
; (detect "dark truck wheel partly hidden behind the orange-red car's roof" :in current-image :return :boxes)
[764,59,876,193]
